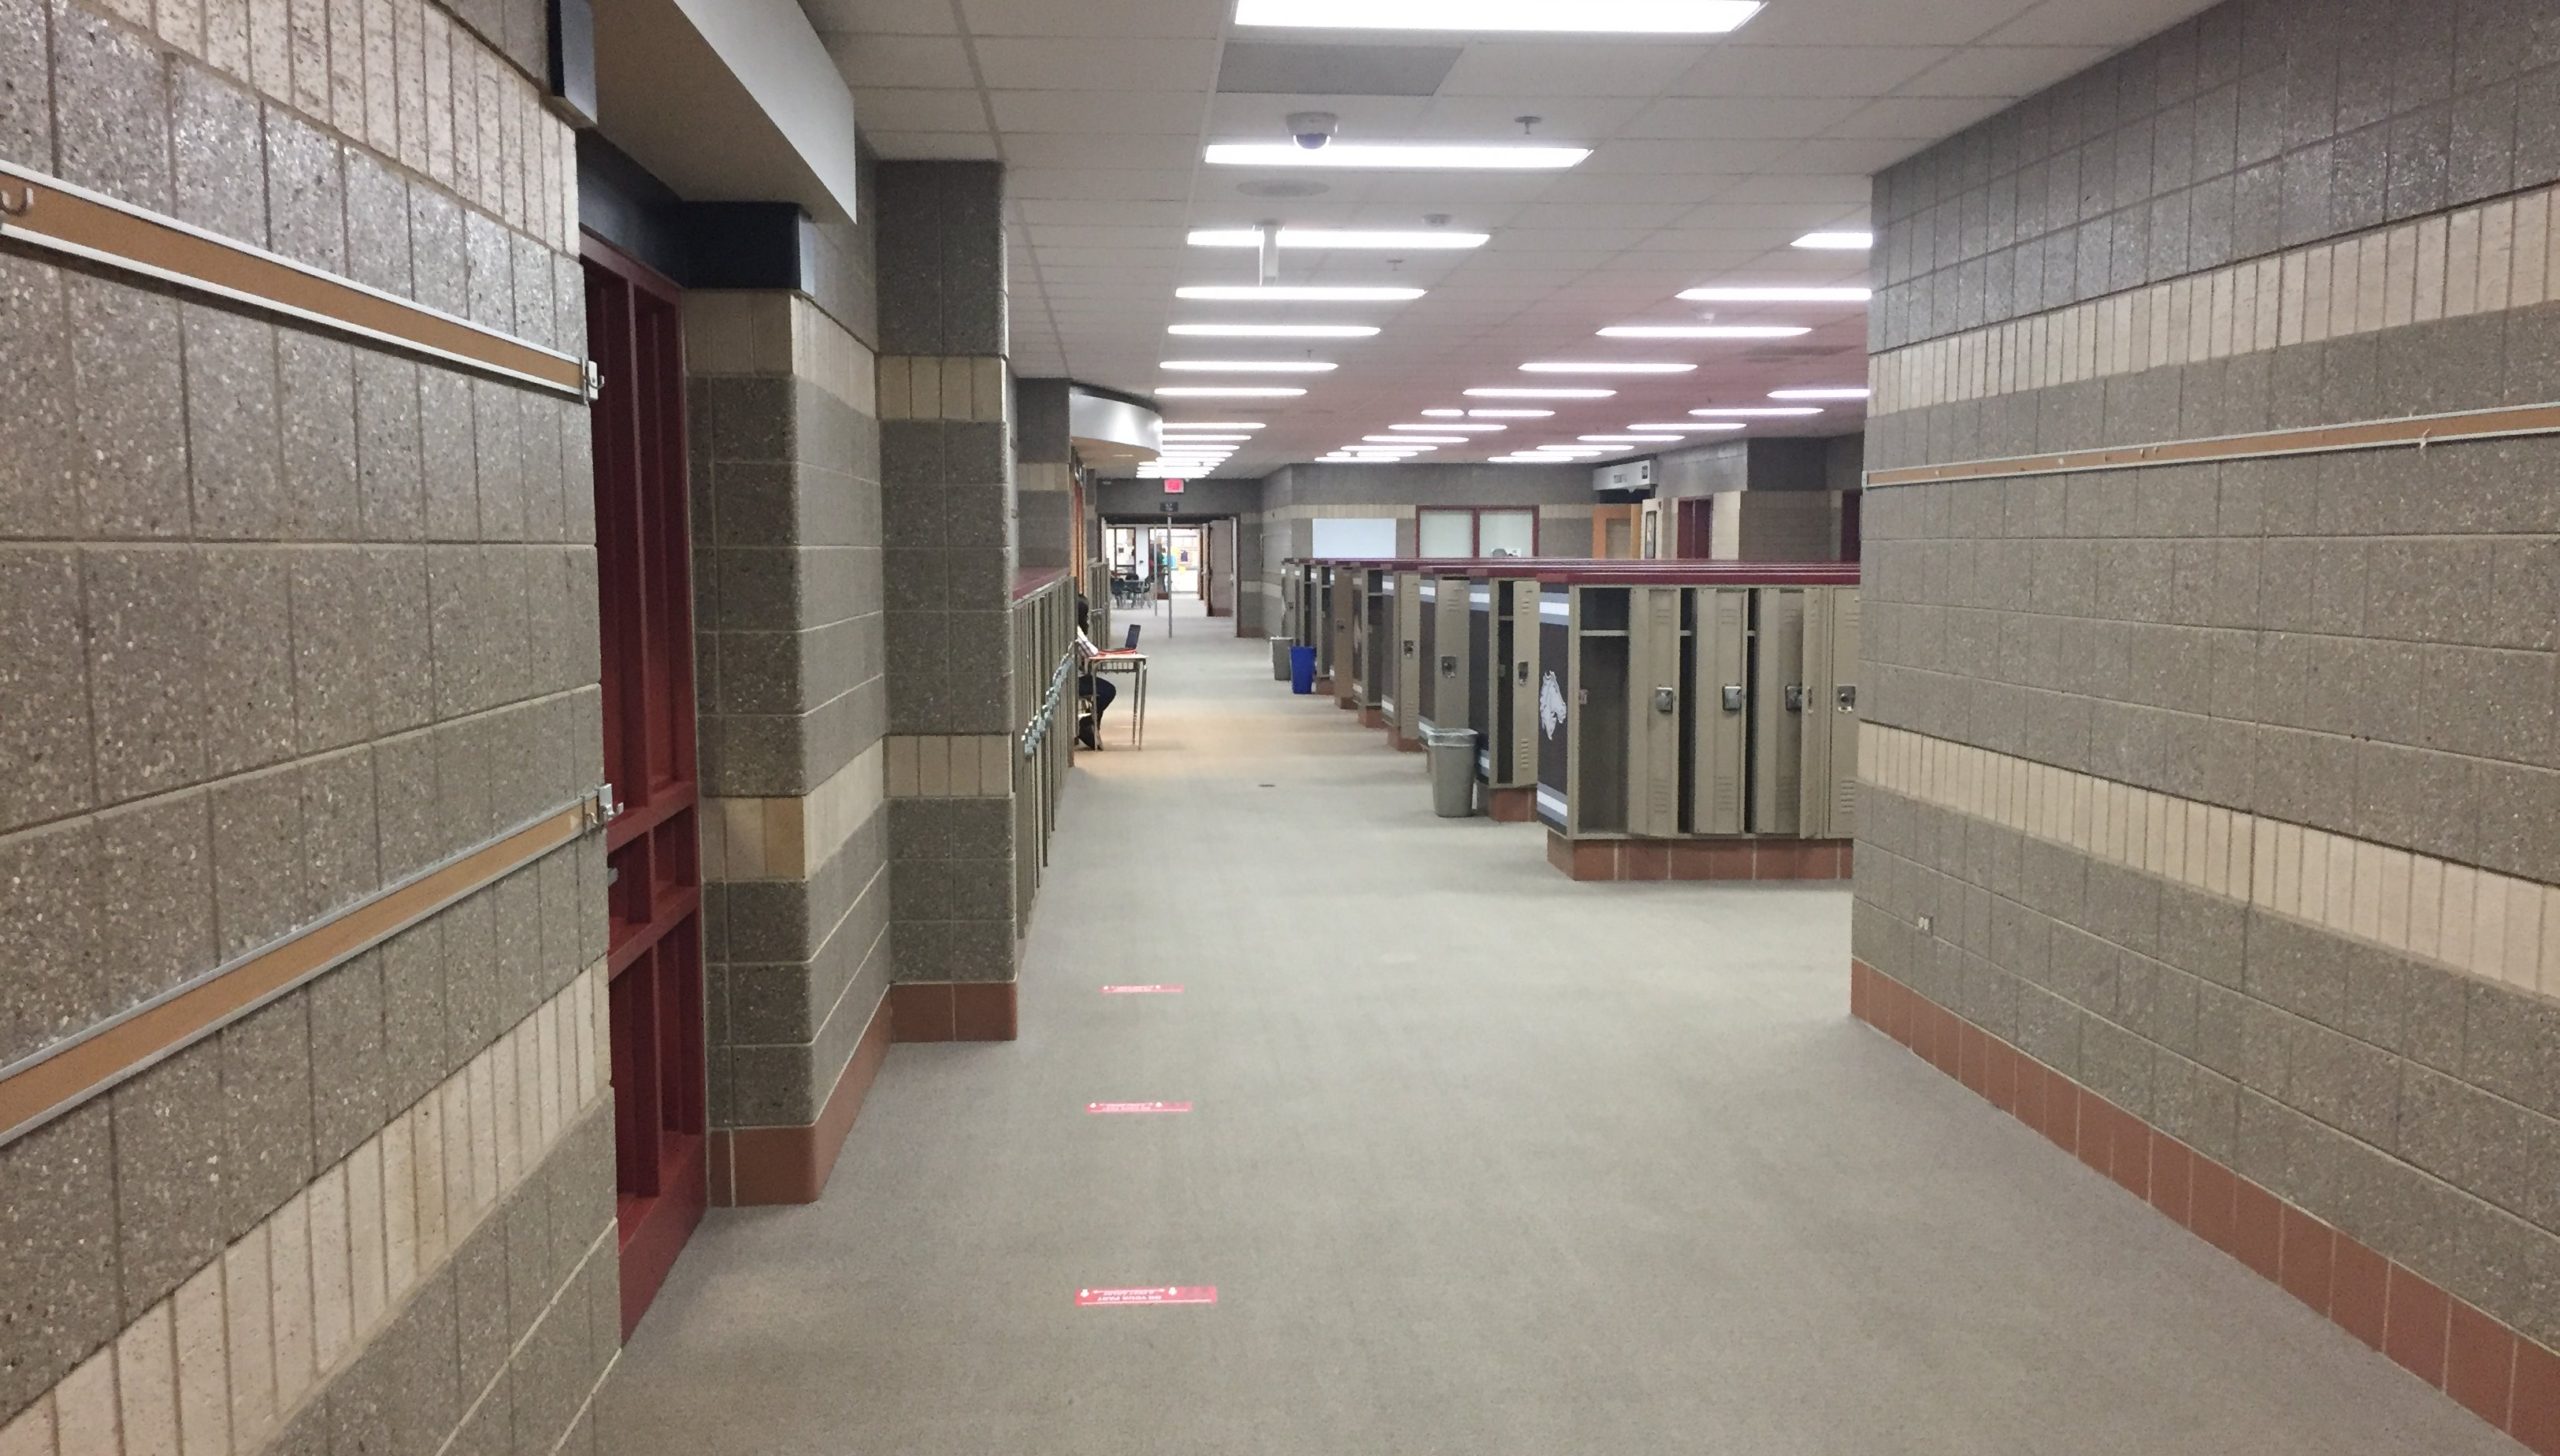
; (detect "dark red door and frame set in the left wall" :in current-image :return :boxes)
[586,238,709,1336]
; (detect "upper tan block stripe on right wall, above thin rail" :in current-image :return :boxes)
[1866,189,2560,415]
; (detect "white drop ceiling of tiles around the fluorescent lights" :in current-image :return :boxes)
[801,0,2204,476]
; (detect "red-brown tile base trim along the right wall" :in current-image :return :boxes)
[1848,960,2560,1456]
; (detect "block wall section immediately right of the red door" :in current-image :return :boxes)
[684,284,891,1203]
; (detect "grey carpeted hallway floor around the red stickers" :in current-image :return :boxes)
[614,606,2514,1456]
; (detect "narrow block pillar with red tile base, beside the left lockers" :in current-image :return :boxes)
[878,161,1021,1039]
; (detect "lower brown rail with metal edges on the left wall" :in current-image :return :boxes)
[0,796,602,1141]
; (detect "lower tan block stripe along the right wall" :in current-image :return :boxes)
[1859,724,2560,998]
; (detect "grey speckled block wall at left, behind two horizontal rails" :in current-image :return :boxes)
[0,0,620,1456]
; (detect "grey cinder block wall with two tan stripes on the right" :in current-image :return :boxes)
[1856,0,2560,1430]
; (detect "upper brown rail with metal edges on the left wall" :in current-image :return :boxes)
[0,161,586,399]
